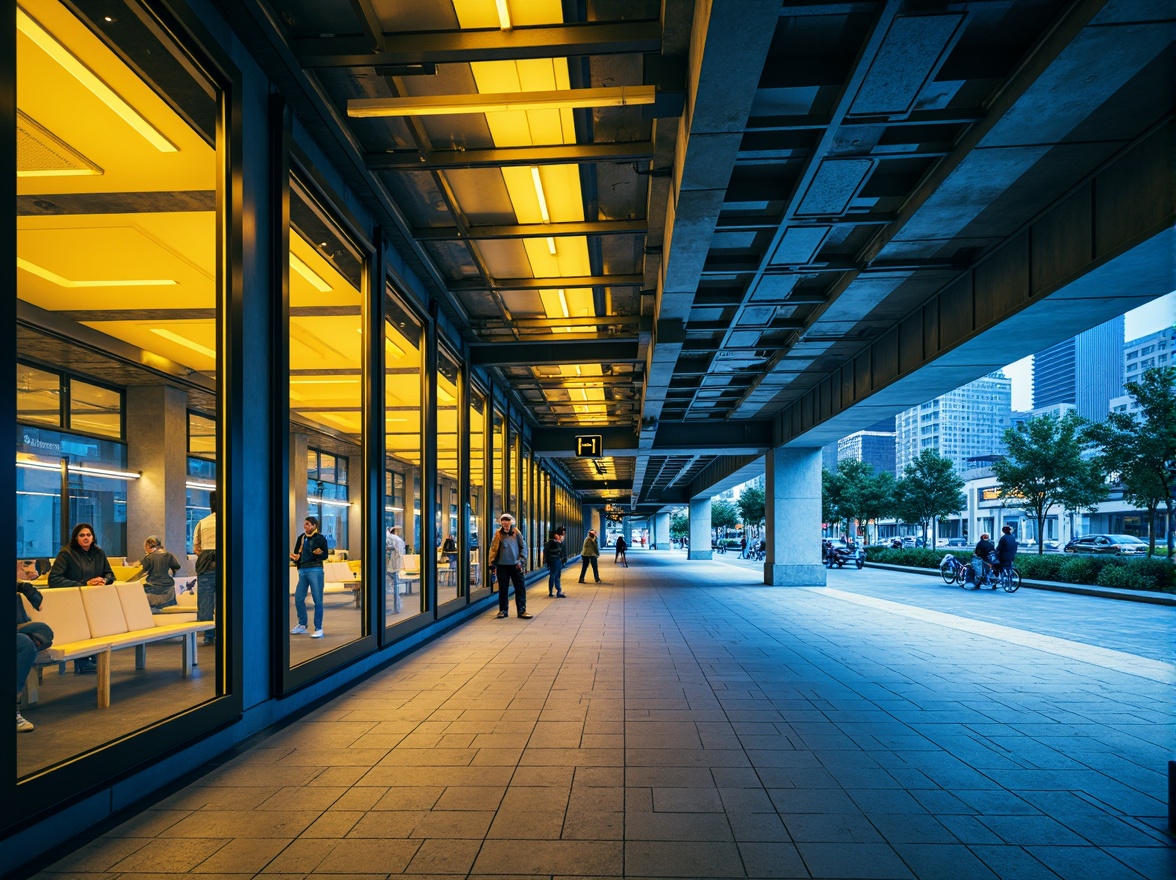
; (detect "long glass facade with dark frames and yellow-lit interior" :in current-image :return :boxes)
[0,0,583,864]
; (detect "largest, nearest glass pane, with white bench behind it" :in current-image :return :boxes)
[15,0,227,776]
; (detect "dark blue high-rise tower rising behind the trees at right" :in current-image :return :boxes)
[1033,315,1124,420]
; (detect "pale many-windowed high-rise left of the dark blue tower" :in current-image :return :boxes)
[895,371,1013,475]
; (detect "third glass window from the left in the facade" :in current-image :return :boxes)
[383,291,432,626]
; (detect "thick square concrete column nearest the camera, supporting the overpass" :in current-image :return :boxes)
[762,447,824,587]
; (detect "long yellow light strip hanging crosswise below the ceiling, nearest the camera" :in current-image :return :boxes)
[347,86,656,119]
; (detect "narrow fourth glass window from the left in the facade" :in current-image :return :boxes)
[434,348,467,605]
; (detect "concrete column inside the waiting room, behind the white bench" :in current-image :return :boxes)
[127,386,188,571]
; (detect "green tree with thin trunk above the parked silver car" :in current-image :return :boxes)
[993,413,1108,553]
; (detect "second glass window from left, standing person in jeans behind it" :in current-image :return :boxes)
[281,172,367,667]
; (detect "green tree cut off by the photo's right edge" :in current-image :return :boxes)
[1087,367,1176,560]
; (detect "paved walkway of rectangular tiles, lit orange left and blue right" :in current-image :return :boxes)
[27,552,1176,880]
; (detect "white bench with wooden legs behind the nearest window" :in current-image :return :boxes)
[22,582,216,709]
